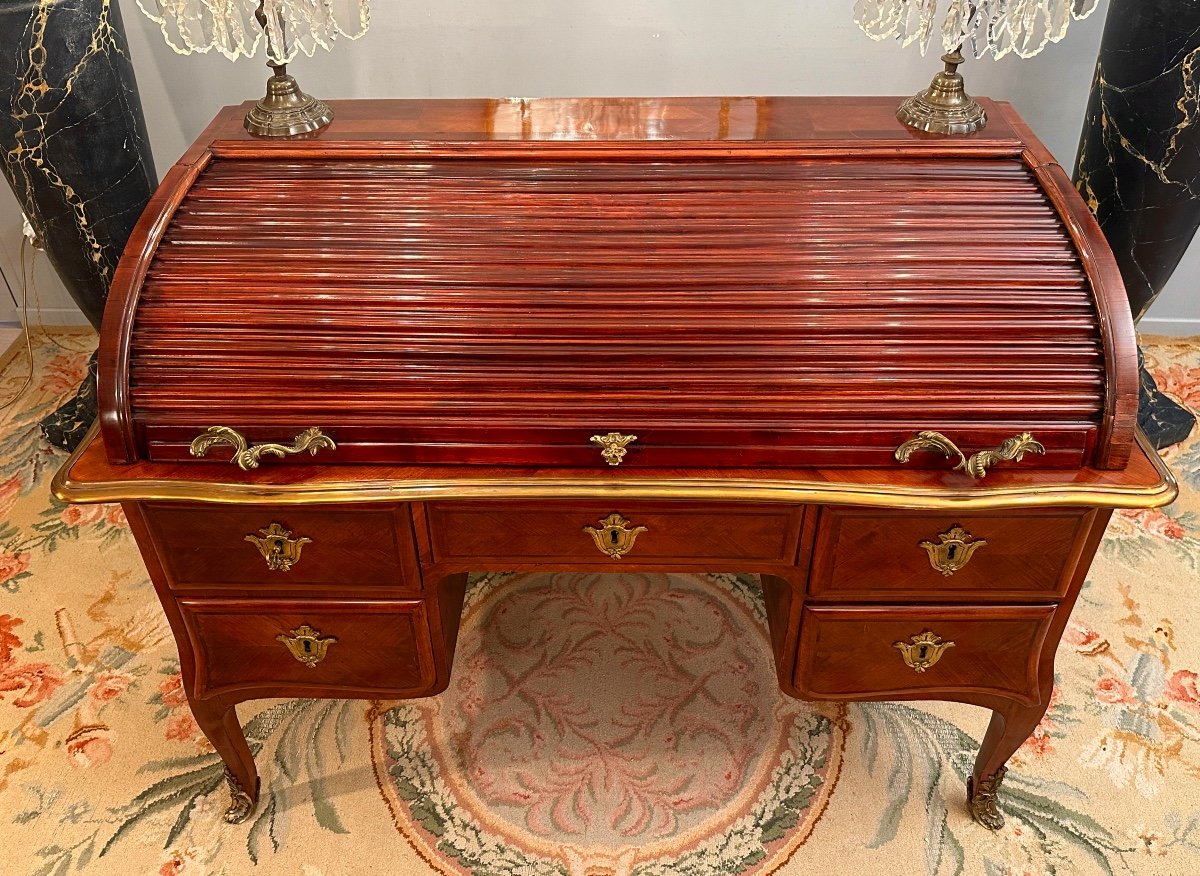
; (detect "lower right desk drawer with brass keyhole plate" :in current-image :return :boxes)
[796,605,1056,704]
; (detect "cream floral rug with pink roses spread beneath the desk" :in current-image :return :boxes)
[0,332,1200,876]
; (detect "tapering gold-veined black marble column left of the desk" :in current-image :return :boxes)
[0,0,158,326]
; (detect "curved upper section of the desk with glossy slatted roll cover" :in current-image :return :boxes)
[101,98,1133,469]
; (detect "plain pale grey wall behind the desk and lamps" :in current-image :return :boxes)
[0,0,1200,335]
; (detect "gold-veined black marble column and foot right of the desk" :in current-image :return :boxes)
[1075,0,1200,448]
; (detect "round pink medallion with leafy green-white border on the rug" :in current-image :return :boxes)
[371,574,845,876]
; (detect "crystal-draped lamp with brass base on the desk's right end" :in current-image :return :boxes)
[854,0,1098,134]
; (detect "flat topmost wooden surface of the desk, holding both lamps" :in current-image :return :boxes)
[182,97,1054,164]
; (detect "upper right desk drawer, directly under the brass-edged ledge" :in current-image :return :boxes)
[809,508,1094,601]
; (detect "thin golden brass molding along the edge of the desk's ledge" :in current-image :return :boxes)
[50,422,1178,511]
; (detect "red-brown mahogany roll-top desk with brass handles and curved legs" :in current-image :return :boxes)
[54,98,1175,828]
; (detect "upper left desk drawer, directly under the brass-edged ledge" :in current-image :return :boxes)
[145,503,421,590]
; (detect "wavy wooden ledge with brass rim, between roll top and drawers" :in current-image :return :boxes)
[52,430,1178,510]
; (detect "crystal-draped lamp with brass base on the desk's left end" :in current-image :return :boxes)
[131,0,371,137]
